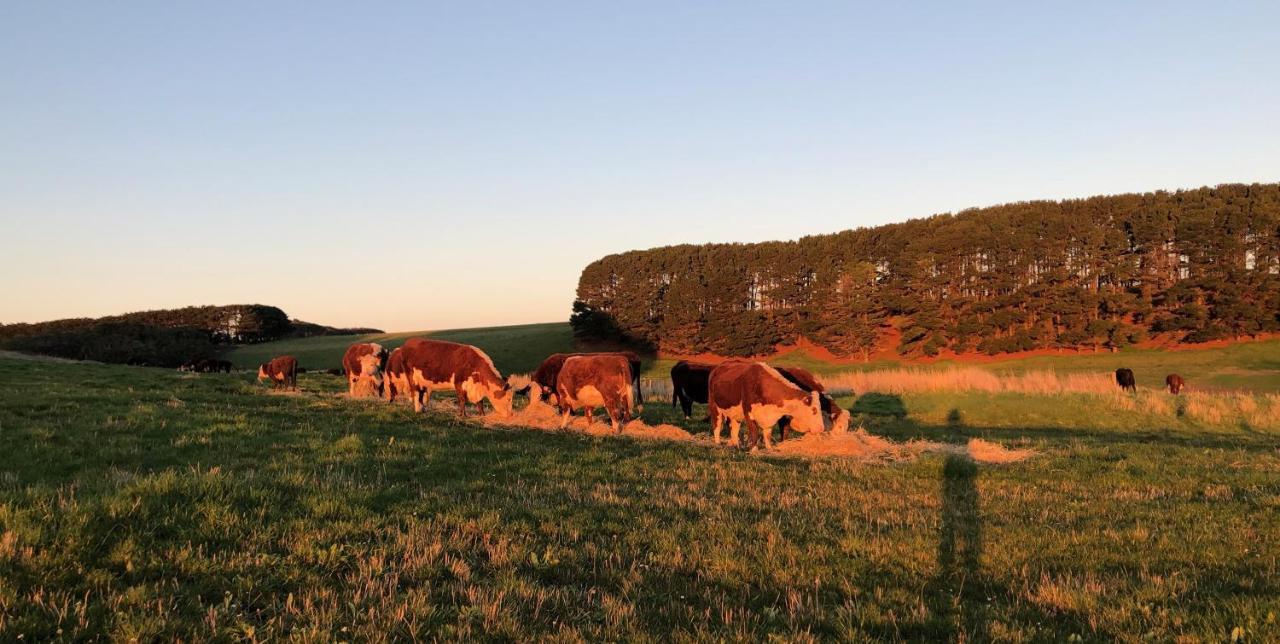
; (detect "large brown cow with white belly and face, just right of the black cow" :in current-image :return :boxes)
[707,361,826,449]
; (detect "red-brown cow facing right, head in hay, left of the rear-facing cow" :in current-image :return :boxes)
[401,338,516,417]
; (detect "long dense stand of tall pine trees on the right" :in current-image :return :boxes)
[571,184,1280,357]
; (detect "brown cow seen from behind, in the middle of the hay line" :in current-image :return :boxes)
[556,353,635,431]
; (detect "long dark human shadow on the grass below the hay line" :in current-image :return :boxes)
[934,455,989,641]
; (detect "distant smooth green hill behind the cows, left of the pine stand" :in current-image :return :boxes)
[227,323,573,374]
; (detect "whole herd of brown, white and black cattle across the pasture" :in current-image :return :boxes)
[241,338,1185,448]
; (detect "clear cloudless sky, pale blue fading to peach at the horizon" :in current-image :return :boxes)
[0,1,1280,330]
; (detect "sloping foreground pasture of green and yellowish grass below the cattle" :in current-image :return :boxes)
[0,350,1280,641]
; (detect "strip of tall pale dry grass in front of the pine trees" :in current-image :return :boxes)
[820,369,1116,396]
